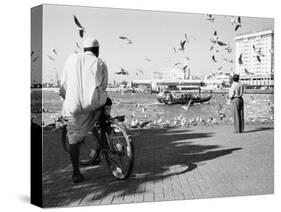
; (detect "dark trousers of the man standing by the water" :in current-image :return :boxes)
[231,97,244,133]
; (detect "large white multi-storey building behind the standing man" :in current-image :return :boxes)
[235,30,274,87]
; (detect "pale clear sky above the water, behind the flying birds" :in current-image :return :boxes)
[32,5,273,82]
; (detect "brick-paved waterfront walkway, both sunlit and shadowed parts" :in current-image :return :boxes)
[43,122,274,207]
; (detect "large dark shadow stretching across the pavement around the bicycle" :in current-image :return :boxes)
[43,126,241,206]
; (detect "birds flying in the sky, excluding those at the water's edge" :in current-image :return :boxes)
[31,14,270,80]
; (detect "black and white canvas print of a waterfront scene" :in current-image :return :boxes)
[30,4,274,207]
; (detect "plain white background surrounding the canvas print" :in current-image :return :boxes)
[0,0,281,212]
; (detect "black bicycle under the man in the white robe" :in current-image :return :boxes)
[61,116,134,180]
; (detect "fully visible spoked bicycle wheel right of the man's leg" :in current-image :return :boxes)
[104,123,134,180]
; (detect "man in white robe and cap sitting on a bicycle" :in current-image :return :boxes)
[60,38,108,183]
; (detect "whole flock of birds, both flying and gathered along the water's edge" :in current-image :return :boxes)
[31,14,274,128]
